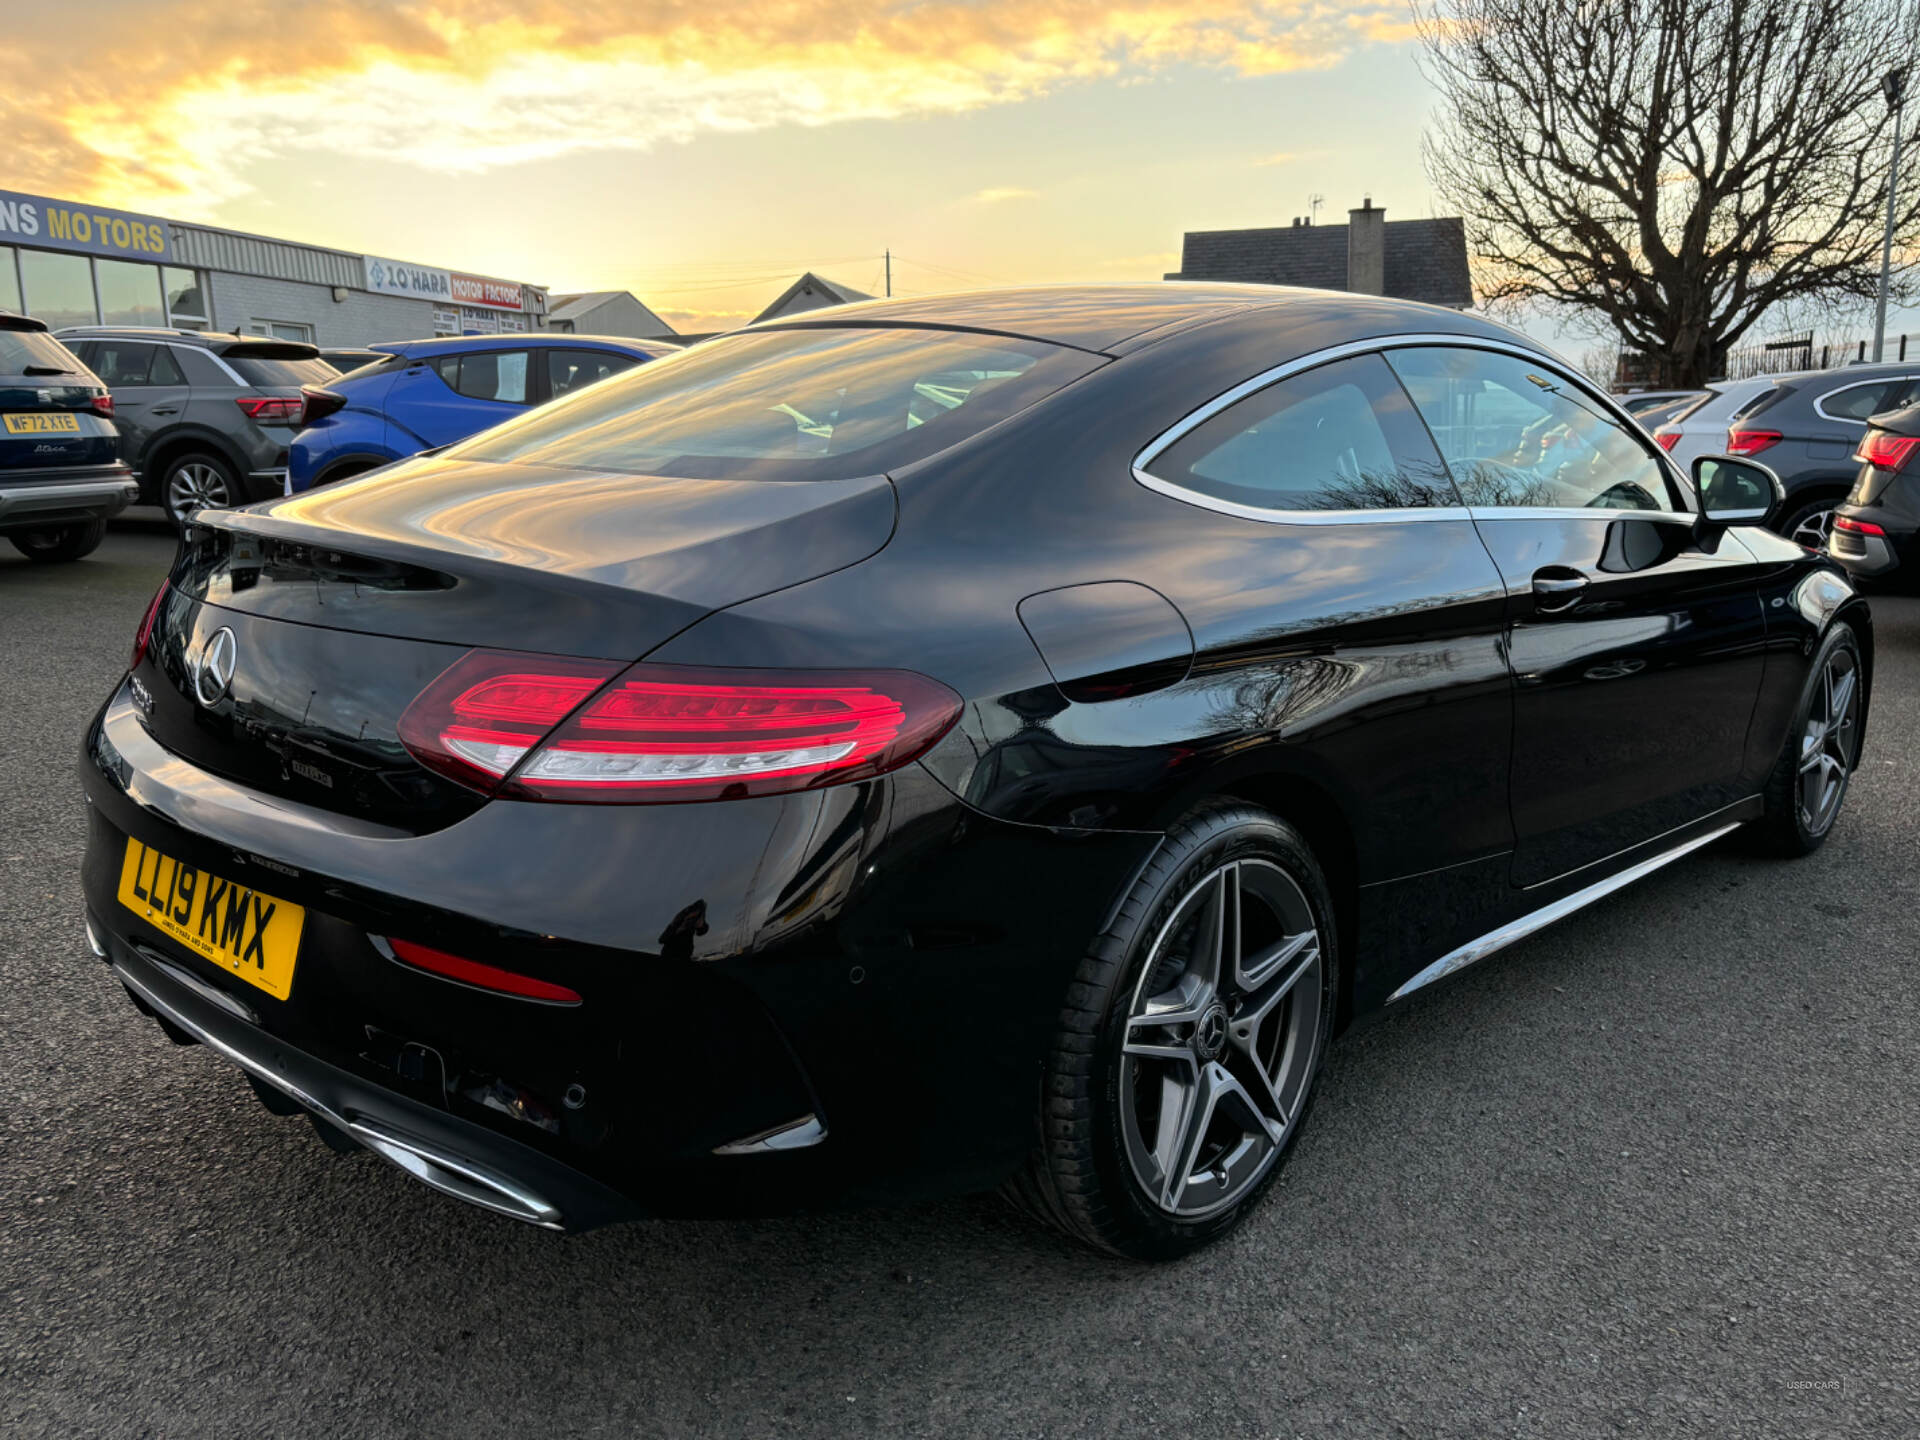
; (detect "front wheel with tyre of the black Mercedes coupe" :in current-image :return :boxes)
[1753,620,1866,856]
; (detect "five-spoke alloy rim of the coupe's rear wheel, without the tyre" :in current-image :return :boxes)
[1119,860,1327,1219]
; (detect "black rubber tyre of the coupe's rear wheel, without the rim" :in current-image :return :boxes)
[1092,806,1340,1260]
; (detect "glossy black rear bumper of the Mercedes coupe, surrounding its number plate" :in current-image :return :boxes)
[81,685,1158,1229]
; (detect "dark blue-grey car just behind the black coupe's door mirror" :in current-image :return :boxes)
[1726,359,1920,549]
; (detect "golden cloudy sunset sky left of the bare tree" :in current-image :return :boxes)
[0,0,1912,341]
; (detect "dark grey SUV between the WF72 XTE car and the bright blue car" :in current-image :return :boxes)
[58,324,334,524]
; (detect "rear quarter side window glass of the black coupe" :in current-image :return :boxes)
[1142,355,1459,511]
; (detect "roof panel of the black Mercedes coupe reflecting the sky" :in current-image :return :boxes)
[749,280,1511,351]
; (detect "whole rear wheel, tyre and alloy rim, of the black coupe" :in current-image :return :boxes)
[1008,803,1338,1260]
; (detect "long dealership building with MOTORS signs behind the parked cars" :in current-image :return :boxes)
[0,190,547,346]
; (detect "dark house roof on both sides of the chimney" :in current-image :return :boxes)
[1167,215,1473,307]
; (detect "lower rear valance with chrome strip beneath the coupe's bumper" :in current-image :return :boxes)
[86,929,641,1231]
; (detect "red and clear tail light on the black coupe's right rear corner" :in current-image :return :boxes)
[399,651,960,804]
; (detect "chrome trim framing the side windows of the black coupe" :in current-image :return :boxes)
[1133,332,1697,524]
